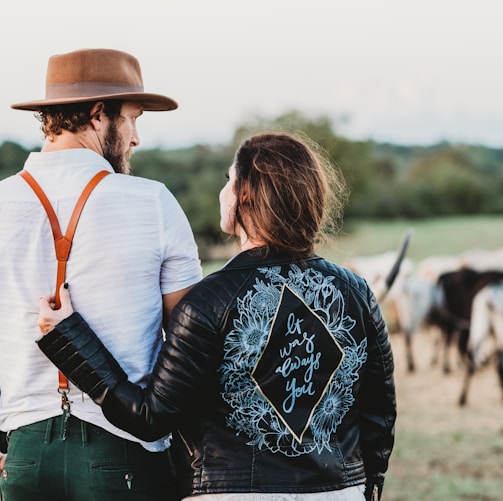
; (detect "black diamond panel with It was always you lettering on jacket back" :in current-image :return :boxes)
[251,284,344,443]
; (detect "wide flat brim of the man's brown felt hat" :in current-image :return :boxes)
[11,92,178,111]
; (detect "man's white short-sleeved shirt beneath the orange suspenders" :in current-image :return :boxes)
[0,149,202,450]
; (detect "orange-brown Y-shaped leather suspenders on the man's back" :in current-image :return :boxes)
[19,170,110,400]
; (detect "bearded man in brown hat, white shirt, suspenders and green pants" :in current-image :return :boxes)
[0,49,202,501]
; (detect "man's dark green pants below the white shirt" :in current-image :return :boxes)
[0,416,179,501]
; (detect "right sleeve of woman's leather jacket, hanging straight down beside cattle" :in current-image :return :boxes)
[360,290,396,500]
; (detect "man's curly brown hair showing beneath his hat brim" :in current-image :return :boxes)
[36,99,123,137]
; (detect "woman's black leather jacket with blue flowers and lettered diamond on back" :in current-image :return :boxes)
[39,251,396,499]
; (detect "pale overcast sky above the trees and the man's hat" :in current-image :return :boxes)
[0,0,503,148]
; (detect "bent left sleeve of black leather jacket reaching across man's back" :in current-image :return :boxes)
[38,294,221,441]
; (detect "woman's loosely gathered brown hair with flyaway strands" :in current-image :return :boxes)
[234,133,347,258]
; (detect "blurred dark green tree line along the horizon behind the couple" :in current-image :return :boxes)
[0,110,503,250]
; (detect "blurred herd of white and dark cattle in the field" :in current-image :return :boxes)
[344,242,503,405]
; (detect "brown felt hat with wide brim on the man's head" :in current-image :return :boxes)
[11,49,178,111]
